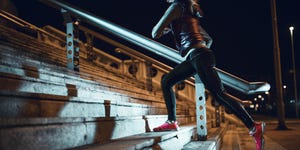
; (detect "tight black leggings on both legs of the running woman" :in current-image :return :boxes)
[161,48,254,129]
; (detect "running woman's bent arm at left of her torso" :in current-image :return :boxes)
[152,3,183,39]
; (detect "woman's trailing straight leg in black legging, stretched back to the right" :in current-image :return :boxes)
[189,48,254,129]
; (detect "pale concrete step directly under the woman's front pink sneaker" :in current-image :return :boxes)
[70,125,195,150]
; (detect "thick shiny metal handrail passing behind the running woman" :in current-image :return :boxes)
[39,0,270,94]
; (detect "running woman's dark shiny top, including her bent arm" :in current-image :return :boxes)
[152,0,212,57]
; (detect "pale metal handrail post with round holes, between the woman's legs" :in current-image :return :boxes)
[195,75,207,141]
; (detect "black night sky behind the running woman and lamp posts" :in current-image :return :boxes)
[12,0,300,94]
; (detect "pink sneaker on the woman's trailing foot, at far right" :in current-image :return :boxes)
[249,122,266,150]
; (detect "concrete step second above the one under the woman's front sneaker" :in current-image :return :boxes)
[0,91,161,118]
